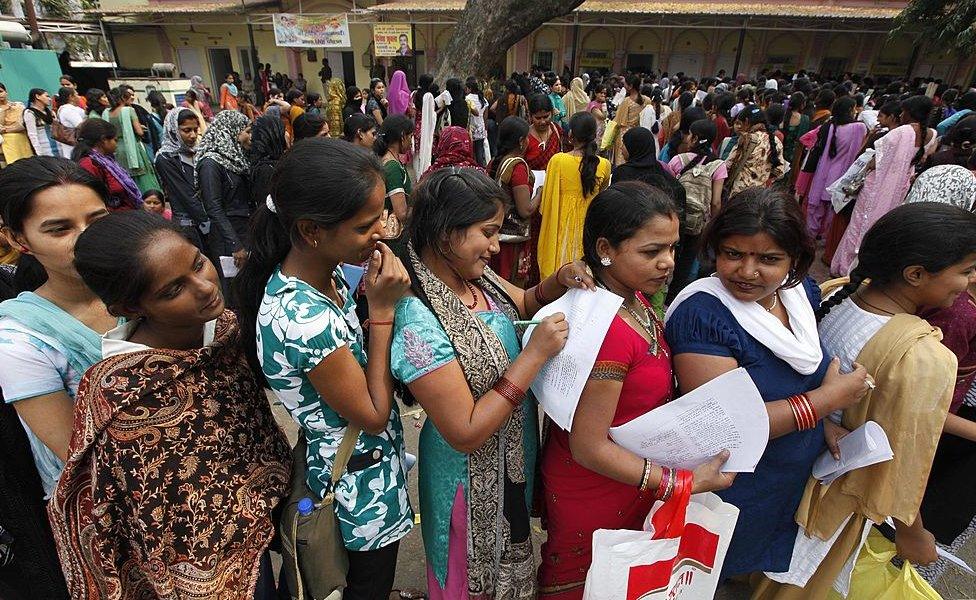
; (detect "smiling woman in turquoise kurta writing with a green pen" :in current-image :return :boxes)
[390,167,593,600]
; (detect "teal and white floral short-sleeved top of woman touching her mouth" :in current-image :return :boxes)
[257,267,414,550]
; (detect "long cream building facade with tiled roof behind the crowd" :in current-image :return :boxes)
[82,0,976,96]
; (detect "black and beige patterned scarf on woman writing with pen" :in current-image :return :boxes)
[408,244,535,599]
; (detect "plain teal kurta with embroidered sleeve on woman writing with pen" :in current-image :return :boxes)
[390,296,539,586]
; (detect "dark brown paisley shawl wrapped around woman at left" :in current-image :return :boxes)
[48,311,291,600]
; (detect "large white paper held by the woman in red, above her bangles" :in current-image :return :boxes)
[610,368,769,473]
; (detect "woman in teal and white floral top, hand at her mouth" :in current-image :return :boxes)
[235,138,414,600]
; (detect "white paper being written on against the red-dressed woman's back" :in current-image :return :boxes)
[522,288,623,431]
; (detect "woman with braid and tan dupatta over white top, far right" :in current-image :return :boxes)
[753,202,976,600]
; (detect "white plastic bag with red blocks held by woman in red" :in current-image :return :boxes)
[583,493,739,600]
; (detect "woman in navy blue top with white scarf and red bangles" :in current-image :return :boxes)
[665,188,867,580]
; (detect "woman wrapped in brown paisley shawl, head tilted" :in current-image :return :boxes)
[48,210,291,600]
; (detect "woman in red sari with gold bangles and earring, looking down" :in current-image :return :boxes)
[539,181,734,600]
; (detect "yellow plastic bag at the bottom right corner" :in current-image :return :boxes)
[829,528,942,600]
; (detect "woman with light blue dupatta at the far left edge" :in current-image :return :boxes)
[0,156,113,496]
